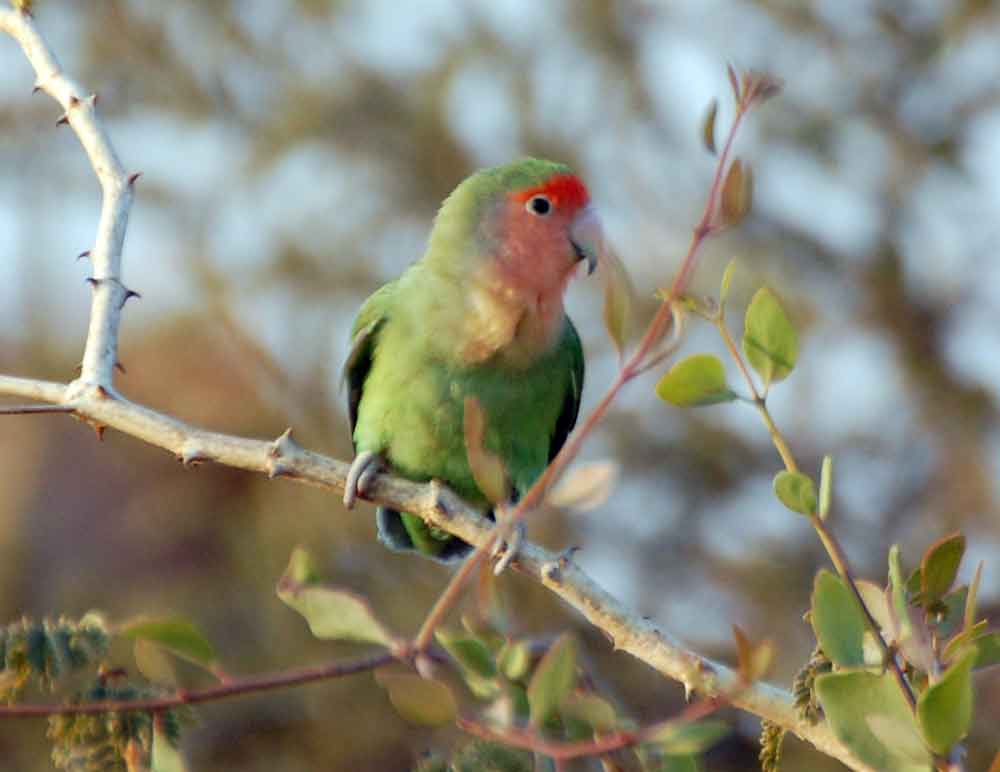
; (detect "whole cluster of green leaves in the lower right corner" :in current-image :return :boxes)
[809,534,1000,770]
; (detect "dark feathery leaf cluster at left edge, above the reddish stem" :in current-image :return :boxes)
[0,615,108,702]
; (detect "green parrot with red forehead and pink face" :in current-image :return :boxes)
[344,158,604,562]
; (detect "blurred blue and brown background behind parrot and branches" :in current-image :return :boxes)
[0,0,1000,770]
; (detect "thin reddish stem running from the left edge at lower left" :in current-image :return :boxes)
[0,652,396,718]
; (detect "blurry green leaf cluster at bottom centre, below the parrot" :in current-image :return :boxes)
[278,544,732,770]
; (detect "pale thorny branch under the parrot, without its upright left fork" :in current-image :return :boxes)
[0,368,864,769]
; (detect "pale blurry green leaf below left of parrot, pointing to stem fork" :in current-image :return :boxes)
[278,568,393,646]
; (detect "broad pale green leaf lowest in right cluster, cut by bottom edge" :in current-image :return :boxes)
[816,671,932,772]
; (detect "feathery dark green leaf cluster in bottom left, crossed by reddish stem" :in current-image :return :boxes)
[46,674,181,772]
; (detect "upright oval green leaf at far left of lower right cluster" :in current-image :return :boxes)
[809,568,866,667]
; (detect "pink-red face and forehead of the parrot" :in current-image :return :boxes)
[495,174,599,305]
